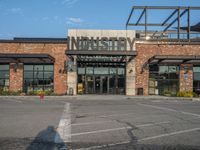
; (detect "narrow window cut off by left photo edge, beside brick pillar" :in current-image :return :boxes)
[0,65,10,91]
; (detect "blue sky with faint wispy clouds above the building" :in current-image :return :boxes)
[0,0,200,39]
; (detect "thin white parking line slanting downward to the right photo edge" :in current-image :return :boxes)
[138,103,200,117]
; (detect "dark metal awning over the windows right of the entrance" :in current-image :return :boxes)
[143,55,200,68]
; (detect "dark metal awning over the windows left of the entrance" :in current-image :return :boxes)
[0,53,55,63]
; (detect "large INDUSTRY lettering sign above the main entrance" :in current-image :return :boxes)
[67,37,135,51]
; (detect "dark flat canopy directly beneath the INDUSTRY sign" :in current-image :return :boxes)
[66,50,137,62]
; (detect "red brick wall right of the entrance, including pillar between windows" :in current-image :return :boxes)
[136,43,200,95]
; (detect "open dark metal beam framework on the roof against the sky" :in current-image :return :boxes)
[126,6,200,40]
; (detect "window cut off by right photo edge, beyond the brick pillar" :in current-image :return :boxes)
[193,66,200,94]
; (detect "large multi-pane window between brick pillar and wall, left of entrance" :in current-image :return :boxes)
[24,64,54,92]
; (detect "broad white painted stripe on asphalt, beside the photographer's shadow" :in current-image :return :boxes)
[54,103,71,143]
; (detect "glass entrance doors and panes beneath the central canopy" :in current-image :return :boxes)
[77,64,125,94]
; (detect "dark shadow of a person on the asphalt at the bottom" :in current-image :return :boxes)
[26,126,67,150]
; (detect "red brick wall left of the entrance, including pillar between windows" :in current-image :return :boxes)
[0,43,67,94]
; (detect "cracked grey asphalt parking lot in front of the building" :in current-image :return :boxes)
[0,95,200,150]
